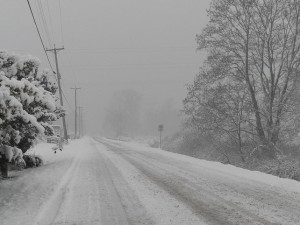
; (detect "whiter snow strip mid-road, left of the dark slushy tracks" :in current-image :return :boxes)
[94,140,207,225]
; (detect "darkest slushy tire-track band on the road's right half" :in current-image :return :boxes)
[96,139,278,225]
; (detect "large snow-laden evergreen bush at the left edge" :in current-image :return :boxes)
[0,51,64,156]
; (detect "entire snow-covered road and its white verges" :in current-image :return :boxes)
[0,138,300,225]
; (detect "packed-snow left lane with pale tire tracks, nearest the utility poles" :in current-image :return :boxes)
[46,141,153,225]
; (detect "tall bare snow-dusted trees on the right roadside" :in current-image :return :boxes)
[183,0,300,162]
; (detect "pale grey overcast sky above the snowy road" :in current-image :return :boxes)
[0,0,210,133]
